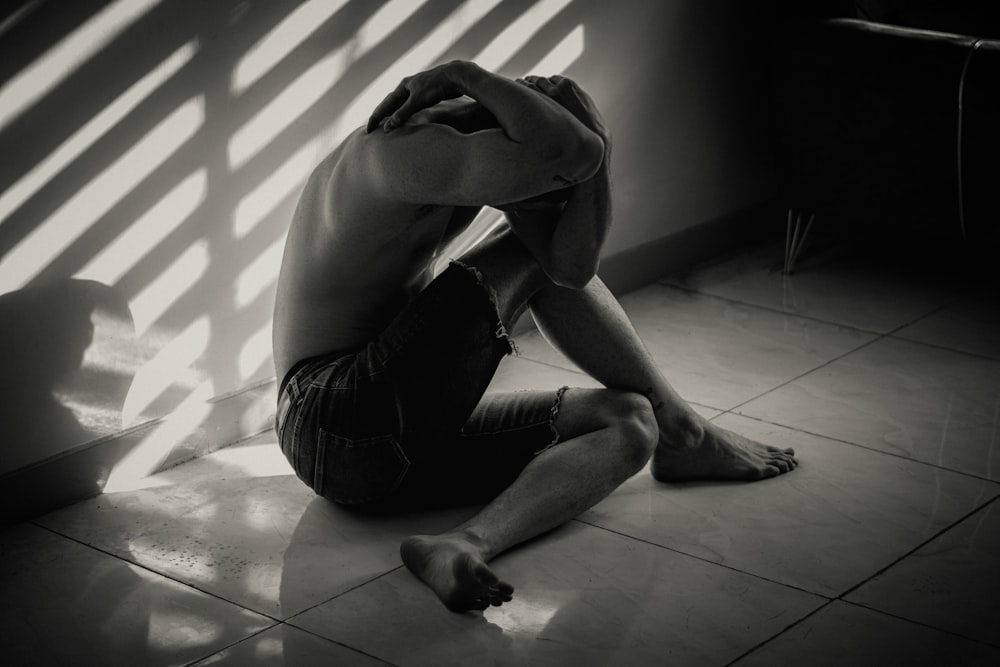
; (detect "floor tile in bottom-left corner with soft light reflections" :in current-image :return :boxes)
[0,526,273,666]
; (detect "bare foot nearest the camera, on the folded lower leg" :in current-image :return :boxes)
[399,533,514,612]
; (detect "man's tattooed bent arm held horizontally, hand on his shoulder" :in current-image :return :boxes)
[356,62,604,206]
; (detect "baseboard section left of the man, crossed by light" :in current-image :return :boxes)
[0,379,275,525]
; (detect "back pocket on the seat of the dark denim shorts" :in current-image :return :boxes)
[313,428,410,505]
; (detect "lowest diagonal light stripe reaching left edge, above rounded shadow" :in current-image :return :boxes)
[0,97,205,292]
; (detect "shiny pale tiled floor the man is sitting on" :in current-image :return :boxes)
[0,237,1000,667]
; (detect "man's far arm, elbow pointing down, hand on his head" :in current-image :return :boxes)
[503,77,611,289]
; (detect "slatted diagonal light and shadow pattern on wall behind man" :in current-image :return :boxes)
[0,0,587,486]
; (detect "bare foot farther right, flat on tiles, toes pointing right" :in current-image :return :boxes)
[652,421,798,482]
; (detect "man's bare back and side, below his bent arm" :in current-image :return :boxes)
[274,125,455,377]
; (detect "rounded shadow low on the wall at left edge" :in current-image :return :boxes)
[0,279,136,470]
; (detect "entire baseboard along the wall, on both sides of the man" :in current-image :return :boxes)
[0,203,780,525]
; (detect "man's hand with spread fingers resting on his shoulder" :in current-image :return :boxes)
[366,60,476,132]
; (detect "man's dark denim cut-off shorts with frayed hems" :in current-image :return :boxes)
[275,263,565,510]
